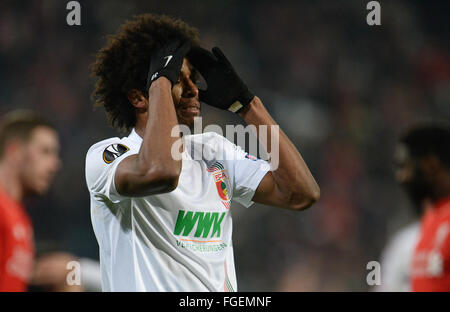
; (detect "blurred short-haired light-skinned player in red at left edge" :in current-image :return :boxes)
[0,111,60,291]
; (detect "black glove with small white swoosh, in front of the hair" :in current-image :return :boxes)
[146,40,191,90]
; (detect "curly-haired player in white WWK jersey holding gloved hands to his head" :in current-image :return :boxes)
[86,14,319,291]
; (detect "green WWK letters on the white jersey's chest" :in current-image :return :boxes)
[173,210,226,238]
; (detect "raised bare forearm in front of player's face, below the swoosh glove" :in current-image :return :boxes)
[138,77,181,176]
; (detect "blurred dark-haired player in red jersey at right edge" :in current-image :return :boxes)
[395,126,450,291]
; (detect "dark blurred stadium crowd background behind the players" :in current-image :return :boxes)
[0,0,450,291]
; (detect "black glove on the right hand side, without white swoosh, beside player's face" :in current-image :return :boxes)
[186,46,254,113]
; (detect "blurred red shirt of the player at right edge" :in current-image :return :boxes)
[411,197,450,291]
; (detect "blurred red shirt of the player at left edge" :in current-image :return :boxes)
[0,189,34,292]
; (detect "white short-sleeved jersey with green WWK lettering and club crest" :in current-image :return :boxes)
[86,129,269,291]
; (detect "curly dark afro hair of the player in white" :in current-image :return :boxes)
[92,14,199,131]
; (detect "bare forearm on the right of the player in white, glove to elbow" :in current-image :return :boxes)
[241,96,320,208]
